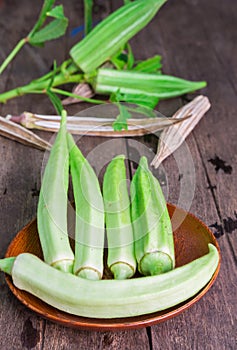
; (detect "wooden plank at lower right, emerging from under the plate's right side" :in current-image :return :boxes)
[152,137,236,349]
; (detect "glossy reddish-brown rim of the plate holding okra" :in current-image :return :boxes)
[5,203,221,331]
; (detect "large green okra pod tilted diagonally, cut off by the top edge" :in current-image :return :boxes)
[70,0,166,73]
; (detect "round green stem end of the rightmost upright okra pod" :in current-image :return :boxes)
[138,251,173,276]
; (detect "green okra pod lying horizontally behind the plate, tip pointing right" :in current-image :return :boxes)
[92,68,206,99]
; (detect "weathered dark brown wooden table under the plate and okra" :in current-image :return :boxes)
[0,0,237,350]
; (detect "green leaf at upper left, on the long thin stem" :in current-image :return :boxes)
[29,5,68,45]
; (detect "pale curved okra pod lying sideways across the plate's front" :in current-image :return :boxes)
[0,244,219,318]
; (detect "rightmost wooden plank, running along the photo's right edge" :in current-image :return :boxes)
[186,1,237,254]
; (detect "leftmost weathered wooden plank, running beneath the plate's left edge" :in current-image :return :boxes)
[0,1,58,349]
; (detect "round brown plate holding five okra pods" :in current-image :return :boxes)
[6,204,220,331]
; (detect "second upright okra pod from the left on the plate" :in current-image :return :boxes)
[67,134,104,280]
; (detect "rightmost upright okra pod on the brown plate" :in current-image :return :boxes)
[131,157,175,275]
